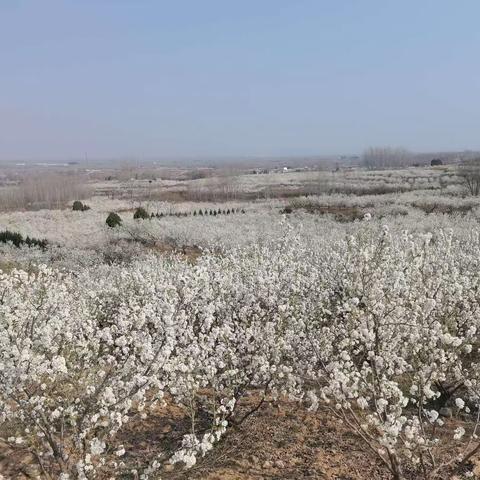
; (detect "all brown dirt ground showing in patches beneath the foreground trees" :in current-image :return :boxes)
[0,404,480,480]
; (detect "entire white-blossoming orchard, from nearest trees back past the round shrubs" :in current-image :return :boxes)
[0,169,480,480]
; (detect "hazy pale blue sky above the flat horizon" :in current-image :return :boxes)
[0,0,480,159]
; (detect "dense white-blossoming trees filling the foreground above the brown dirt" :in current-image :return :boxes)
[0,227,480,479]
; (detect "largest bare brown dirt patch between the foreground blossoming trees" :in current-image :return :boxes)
[182,406,389,480]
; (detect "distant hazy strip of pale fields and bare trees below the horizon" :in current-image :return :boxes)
[0,154,472,210]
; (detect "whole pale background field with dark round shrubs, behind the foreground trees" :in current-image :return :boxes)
[0,158,474,263]
